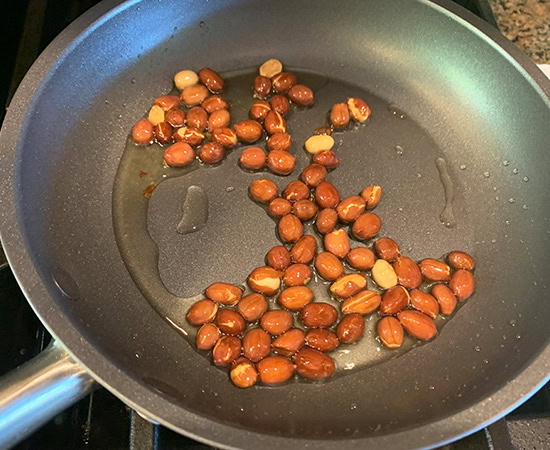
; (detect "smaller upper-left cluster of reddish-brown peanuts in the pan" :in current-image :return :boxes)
[132,59,320,171]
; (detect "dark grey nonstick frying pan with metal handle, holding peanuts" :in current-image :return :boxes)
[0,0,550,448]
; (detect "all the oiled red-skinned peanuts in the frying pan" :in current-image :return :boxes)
[165,59,475,388]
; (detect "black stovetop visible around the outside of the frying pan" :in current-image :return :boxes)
[0,0,550,450]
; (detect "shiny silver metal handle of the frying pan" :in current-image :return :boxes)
[0,340,96,448]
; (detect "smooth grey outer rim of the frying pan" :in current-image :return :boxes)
[0,0,550,448]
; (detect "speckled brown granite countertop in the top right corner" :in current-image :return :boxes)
[491,0,550,64]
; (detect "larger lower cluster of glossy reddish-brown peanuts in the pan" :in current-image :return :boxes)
[187,167,475,388]
